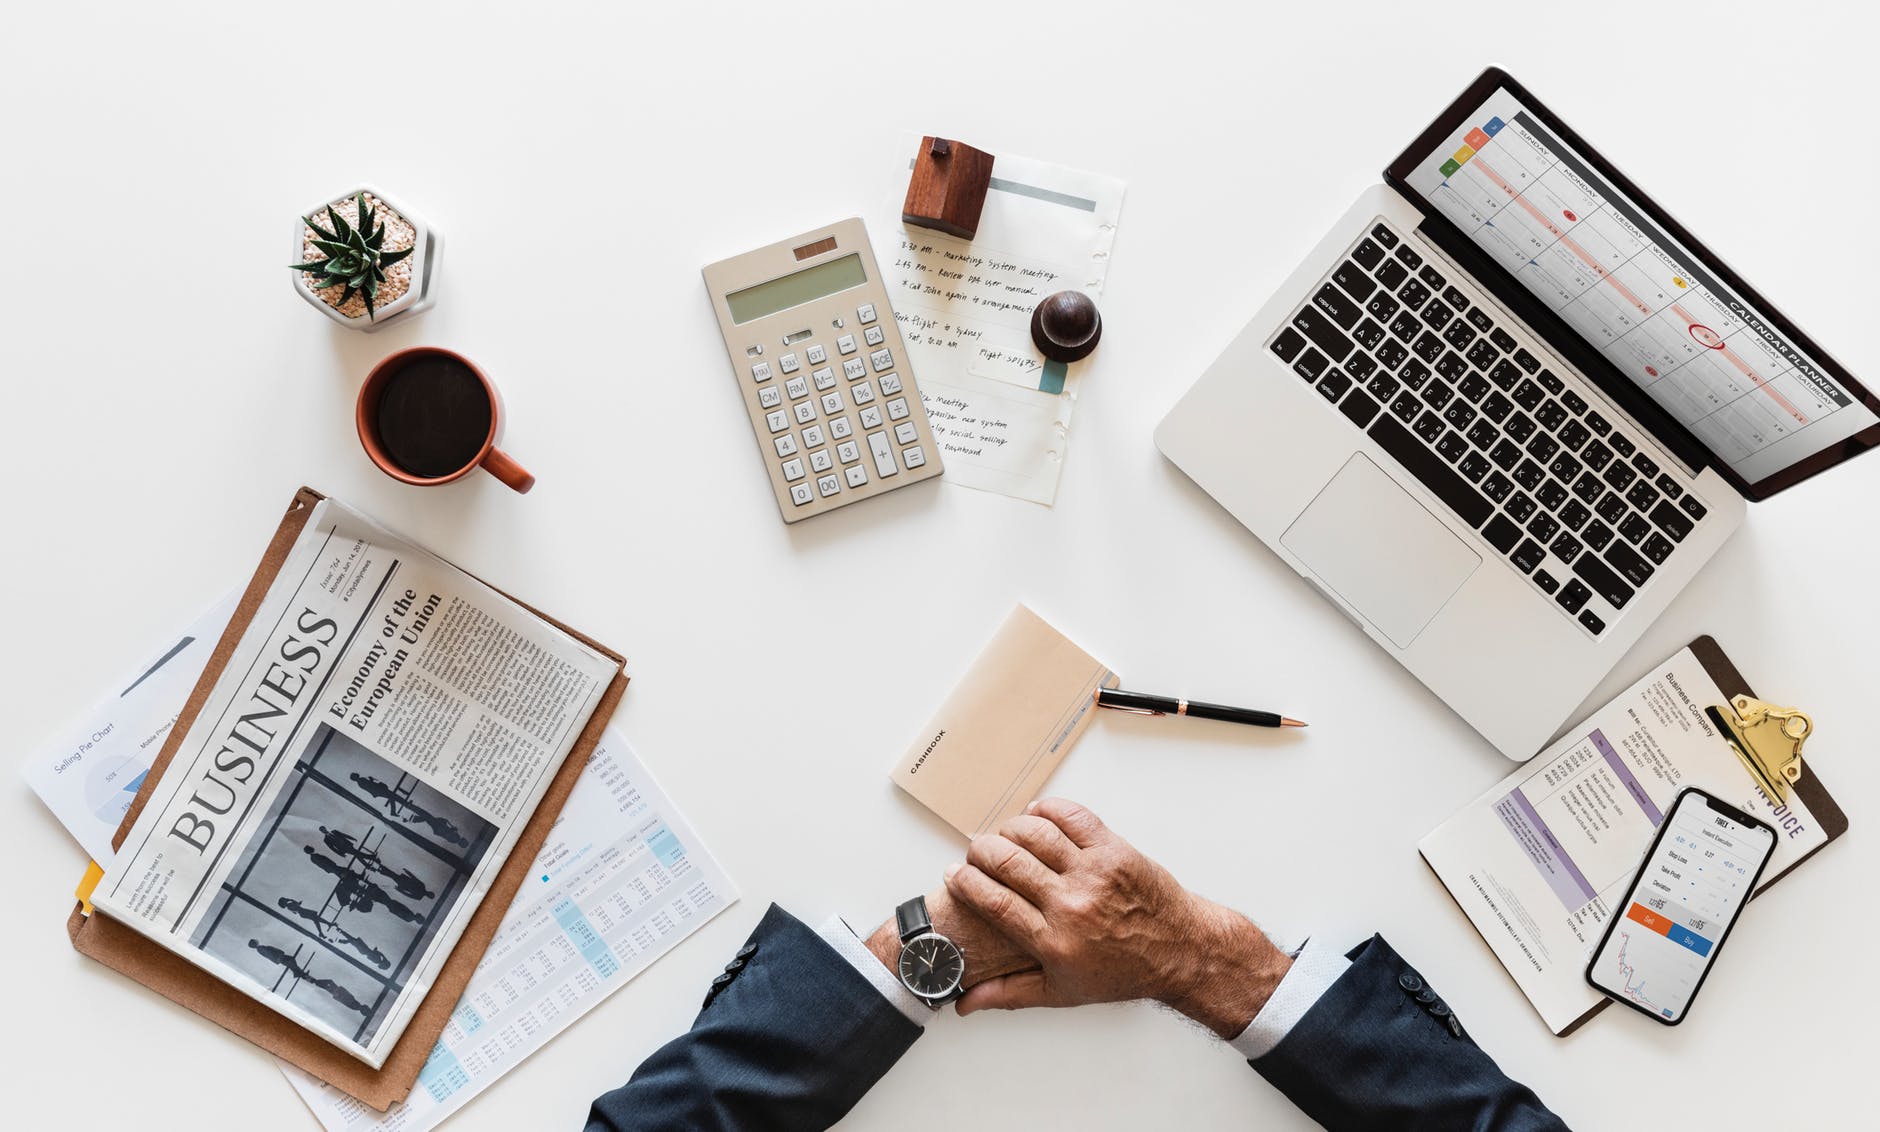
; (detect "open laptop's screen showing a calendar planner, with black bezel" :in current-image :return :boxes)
[1391,71,1880,495]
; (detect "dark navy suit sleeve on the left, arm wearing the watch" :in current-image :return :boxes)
[587,904,921,1132]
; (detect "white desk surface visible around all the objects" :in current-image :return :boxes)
[0,2,1880,1132]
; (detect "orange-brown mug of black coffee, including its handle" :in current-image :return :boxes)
[357,346,536,491]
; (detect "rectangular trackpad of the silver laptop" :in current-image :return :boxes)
[1280,453,1481,649]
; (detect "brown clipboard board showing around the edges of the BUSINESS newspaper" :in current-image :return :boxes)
[66,487,628,1111]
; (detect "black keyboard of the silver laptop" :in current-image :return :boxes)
[1269,220,1705,636]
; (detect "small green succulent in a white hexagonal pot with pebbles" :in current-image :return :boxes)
[290,186,444,331]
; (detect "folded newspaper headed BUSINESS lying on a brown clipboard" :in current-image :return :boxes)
[92,500,617,1068]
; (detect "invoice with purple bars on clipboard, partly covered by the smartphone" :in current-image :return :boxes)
[1418,649,1842,1034]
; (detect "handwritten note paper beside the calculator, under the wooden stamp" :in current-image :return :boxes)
[876,139,1122,506]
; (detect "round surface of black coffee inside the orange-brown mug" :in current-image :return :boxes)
[374,354,493,480]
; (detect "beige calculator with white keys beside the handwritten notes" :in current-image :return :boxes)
[705,216,940,523]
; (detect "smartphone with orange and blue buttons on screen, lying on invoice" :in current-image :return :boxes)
[1587,786,1775,1027]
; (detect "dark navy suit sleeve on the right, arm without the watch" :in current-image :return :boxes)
[1248,936,1566,1132]
